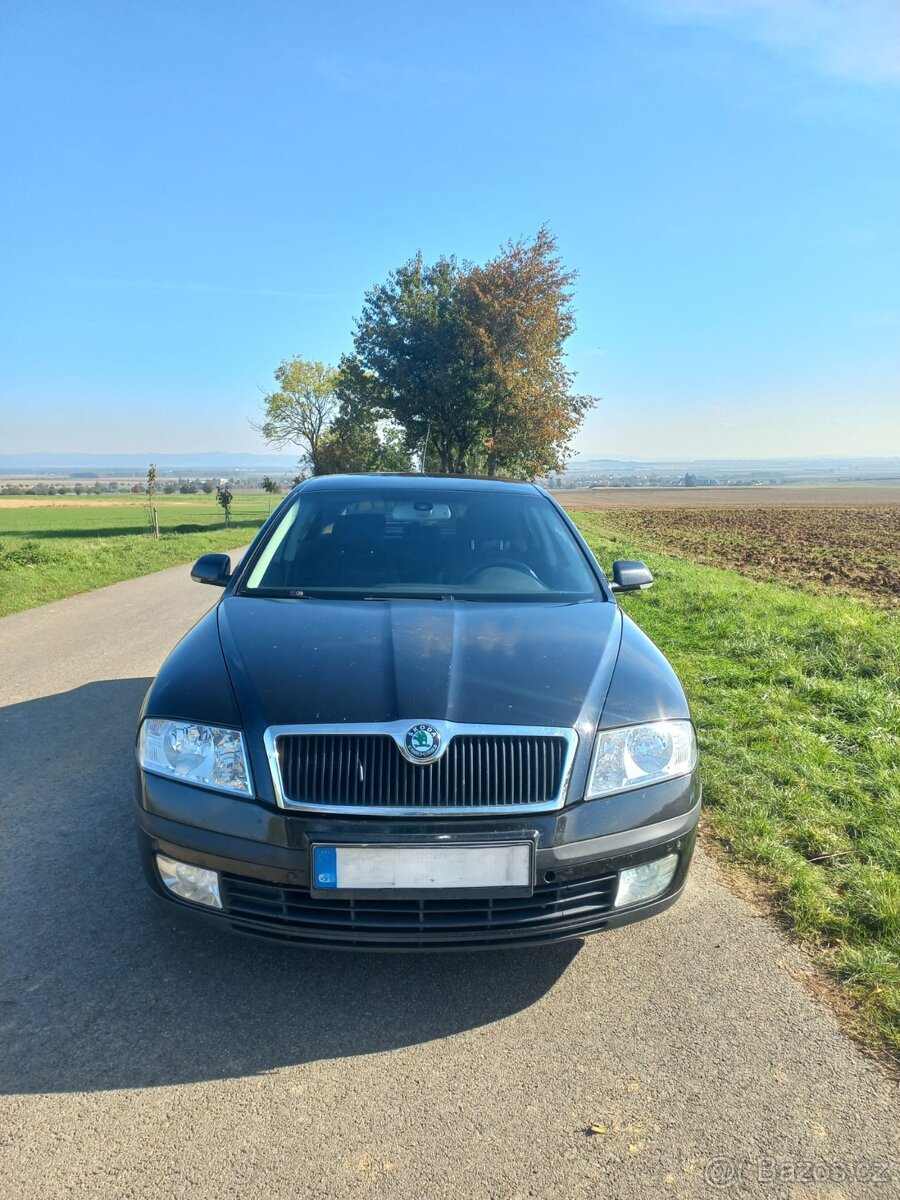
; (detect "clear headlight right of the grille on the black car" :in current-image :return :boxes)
[586,721,697,800]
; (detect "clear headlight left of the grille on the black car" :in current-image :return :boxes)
[138,718,251,796]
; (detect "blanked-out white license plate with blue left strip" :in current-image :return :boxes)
[312,841,534,895]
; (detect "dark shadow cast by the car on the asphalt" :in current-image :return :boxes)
[0,679,582,1092]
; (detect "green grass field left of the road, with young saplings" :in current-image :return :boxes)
[0,493,269,617]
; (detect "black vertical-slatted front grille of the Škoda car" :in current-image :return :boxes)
[269,722,575,812]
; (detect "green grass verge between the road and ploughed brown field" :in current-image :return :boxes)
[572,512,900,1051]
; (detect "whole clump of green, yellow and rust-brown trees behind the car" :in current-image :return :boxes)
[256,227,594,478]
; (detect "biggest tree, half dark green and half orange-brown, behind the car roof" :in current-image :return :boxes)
[342,226,594,478]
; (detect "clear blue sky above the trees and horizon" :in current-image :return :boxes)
[0,0,900,457]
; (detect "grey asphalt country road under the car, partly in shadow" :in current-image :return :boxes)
[0,556,900,1200]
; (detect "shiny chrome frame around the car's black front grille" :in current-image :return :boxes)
[264,716,578,817]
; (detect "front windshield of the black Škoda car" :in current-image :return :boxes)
[239,485,601,601]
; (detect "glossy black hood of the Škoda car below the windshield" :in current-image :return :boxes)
[217,596,622,737]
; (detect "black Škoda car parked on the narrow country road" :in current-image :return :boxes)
[136,475,701,949]
